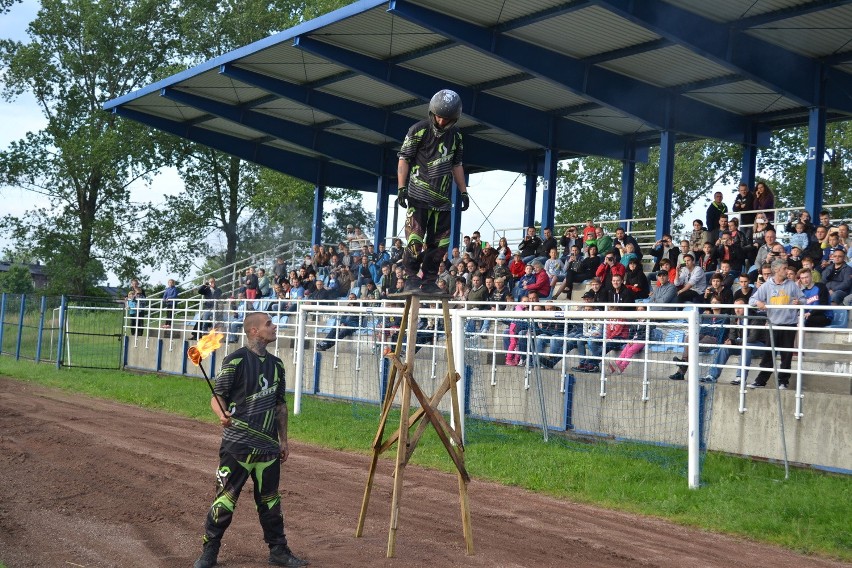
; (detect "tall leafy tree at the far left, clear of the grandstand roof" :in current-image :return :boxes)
[0,0,177,294]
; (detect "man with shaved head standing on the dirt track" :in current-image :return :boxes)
[195,312,308,568]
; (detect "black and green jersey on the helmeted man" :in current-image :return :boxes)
[397,118,464,211]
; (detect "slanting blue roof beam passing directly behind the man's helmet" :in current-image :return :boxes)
[295,36,624,160]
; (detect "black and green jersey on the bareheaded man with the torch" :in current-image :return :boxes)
[213,347,285,456]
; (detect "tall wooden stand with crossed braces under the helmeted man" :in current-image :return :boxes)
[355,292,473,558]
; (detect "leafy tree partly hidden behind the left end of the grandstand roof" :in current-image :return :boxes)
[145,0,348,271]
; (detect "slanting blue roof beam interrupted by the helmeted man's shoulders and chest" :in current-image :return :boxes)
[219,64,526,172]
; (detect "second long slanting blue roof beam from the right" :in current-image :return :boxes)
[389,0,747,142]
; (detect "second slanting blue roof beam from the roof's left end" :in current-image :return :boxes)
[160,88,396,175]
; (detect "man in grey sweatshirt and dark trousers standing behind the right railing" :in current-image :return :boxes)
[748,259,805,390]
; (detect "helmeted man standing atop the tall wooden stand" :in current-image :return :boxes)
[397,89,470,293]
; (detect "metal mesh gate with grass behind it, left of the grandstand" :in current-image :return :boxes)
[51,297,124,369]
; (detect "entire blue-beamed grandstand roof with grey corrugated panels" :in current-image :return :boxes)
[105,0,852,195]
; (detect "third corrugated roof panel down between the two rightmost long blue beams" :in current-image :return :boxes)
[601,45,731,87]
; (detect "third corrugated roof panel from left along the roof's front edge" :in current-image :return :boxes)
[235,43,347,84]
